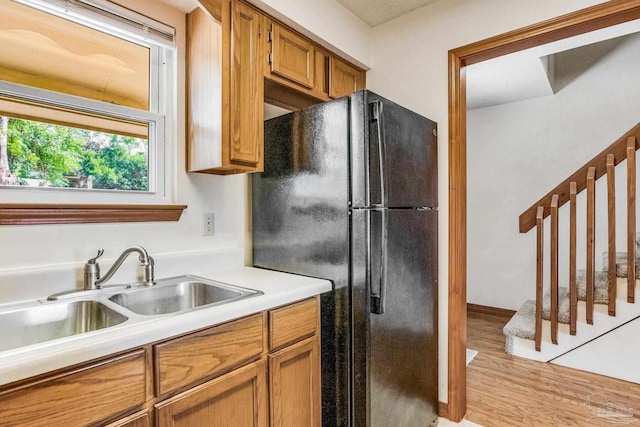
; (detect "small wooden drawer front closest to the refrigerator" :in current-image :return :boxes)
[269,298,318,350]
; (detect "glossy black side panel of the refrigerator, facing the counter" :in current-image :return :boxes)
[252,98,350,426]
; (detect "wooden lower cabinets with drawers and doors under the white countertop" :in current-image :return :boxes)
[0,297,321,427]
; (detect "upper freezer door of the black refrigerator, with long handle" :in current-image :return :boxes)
[351,91,438,208]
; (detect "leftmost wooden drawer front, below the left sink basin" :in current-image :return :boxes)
[0,350,146,427]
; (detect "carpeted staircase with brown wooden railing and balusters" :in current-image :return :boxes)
[503,123,640,361]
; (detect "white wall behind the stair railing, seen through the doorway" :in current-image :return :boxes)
[467,35,640,310]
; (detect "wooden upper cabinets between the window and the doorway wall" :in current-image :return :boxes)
[186,0,365,175]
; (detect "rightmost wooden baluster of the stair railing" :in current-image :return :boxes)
[627,136,636,302]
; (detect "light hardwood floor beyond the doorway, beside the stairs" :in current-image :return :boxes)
[465,311,640,427]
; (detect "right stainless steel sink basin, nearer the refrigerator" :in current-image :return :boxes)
[109,276,262,316]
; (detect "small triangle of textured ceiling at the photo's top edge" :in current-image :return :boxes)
[337,0,437,27]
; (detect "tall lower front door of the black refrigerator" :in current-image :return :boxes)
[352,209,438,427]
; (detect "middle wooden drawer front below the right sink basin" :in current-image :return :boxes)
[154,314,264,395]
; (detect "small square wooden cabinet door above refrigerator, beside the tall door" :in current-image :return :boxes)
[271,24,315,88]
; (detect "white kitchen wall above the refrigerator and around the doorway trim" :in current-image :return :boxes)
[367,0,601,402]
